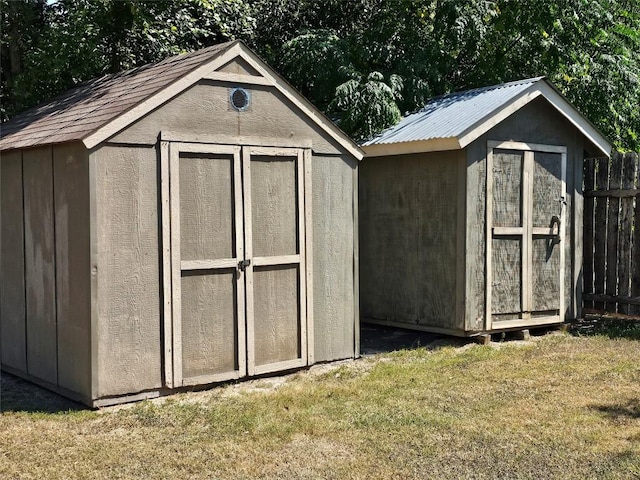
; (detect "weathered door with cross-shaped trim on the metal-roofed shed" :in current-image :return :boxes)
[485,142,567,330]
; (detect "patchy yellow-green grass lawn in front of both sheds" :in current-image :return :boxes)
[0,327,640,479]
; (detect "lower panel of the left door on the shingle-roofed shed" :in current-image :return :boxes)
[181,268,239,378]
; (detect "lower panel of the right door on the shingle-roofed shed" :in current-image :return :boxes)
[253,265,301,366]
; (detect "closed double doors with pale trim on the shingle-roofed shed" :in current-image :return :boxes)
[163,143,311,387]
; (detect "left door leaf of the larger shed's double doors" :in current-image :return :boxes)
[171,144,246,386]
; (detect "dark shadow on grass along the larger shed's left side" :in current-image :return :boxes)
[0,372,87,413]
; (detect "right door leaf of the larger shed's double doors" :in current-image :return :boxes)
[243,148,307,374]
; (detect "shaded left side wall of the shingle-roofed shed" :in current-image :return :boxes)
[0,144,91,399]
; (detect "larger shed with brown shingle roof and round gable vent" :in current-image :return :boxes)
[0,42,362,406]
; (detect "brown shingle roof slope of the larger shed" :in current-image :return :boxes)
[0,42,234,150]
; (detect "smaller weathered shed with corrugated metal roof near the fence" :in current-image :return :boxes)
[360,77,611,336]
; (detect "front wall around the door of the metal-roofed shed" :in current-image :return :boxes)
[466,98,583,331]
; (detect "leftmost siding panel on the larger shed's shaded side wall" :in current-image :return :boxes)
[0,151,27,373]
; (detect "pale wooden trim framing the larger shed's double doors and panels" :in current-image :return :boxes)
[159,140,314,388]
